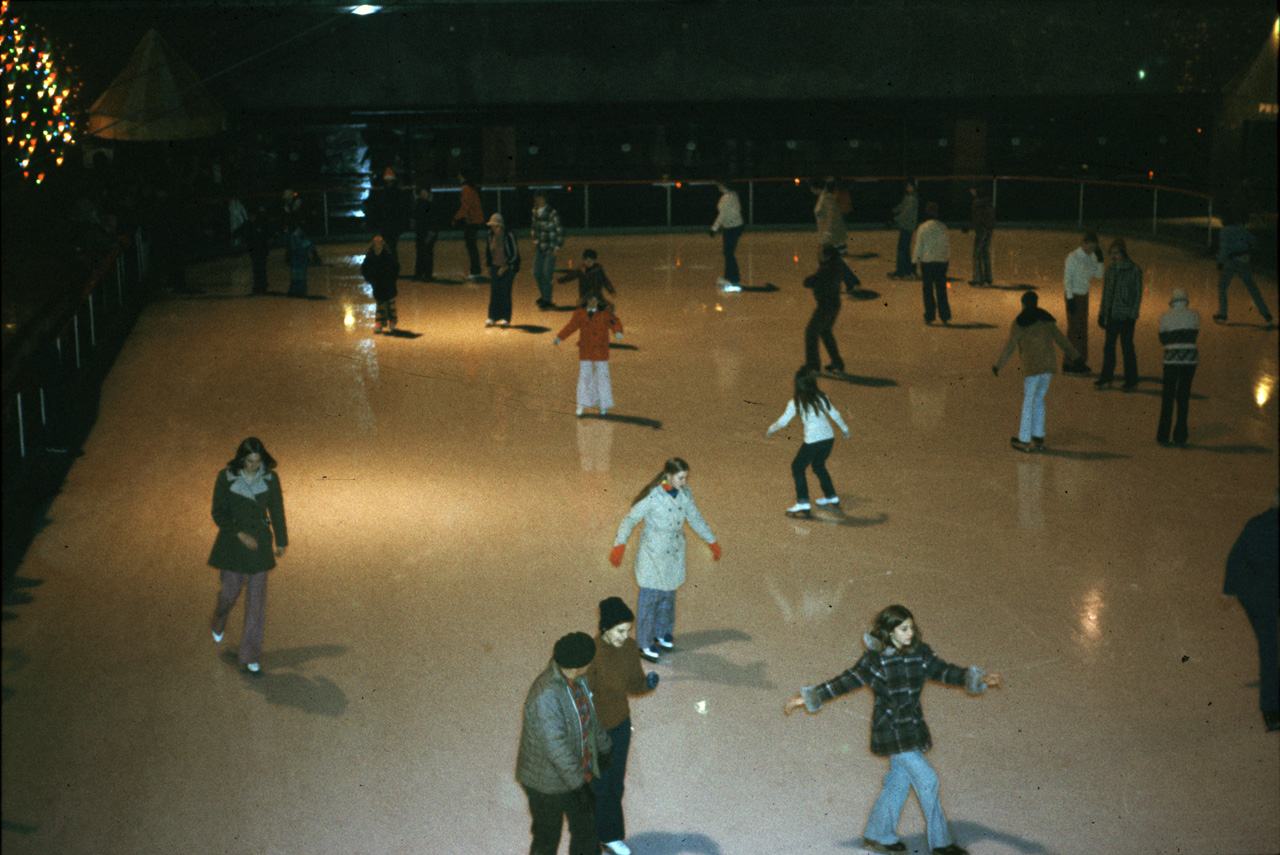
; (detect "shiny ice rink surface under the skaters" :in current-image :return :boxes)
[3,230,1280,855]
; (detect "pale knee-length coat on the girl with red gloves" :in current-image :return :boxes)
[613,484,716,591]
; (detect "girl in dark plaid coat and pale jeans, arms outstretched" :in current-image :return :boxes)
[782,605,1000,855]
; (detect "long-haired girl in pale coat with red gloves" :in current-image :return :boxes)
[609,457,721,662]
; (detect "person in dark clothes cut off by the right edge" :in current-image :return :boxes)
[1222,489,1280,732]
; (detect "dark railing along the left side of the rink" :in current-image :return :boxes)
[4,232,147,483]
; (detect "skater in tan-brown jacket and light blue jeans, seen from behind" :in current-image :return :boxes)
[991,291,1082,452]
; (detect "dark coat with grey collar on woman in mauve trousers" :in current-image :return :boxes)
[209,468,289,573]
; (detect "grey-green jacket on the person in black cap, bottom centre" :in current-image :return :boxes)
[516,660,613,795]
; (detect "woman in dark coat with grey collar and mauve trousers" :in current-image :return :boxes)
[209,436,289,673]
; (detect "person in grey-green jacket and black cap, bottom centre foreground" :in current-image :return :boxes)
[516,632,613,855]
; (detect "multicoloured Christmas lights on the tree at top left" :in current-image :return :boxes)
[0,0,79,184]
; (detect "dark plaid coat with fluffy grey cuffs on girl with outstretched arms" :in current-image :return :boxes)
[800,635,987,756]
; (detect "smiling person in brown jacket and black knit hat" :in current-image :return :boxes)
[586,596,658,855]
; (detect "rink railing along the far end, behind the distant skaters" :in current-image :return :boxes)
[244,175,1216,247]
